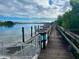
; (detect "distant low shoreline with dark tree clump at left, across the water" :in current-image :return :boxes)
[0,21,50,27]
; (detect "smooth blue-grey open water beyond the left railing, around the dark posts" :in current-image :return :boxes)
[0,24,43,46]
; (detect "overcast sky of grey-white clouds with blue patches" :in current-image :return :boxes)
[0,0,71,18]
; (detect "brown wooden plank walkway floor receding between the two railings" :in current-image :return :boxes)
[38,28,75,59]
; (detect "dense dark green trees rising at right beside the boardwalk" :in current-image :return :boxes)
[57,1,79,31]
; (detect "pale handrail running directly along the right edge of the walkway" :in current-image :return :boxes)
[58,26,79,54]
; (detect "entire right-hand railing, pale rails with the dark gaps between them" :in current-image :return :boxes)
[57,26,79,59]
